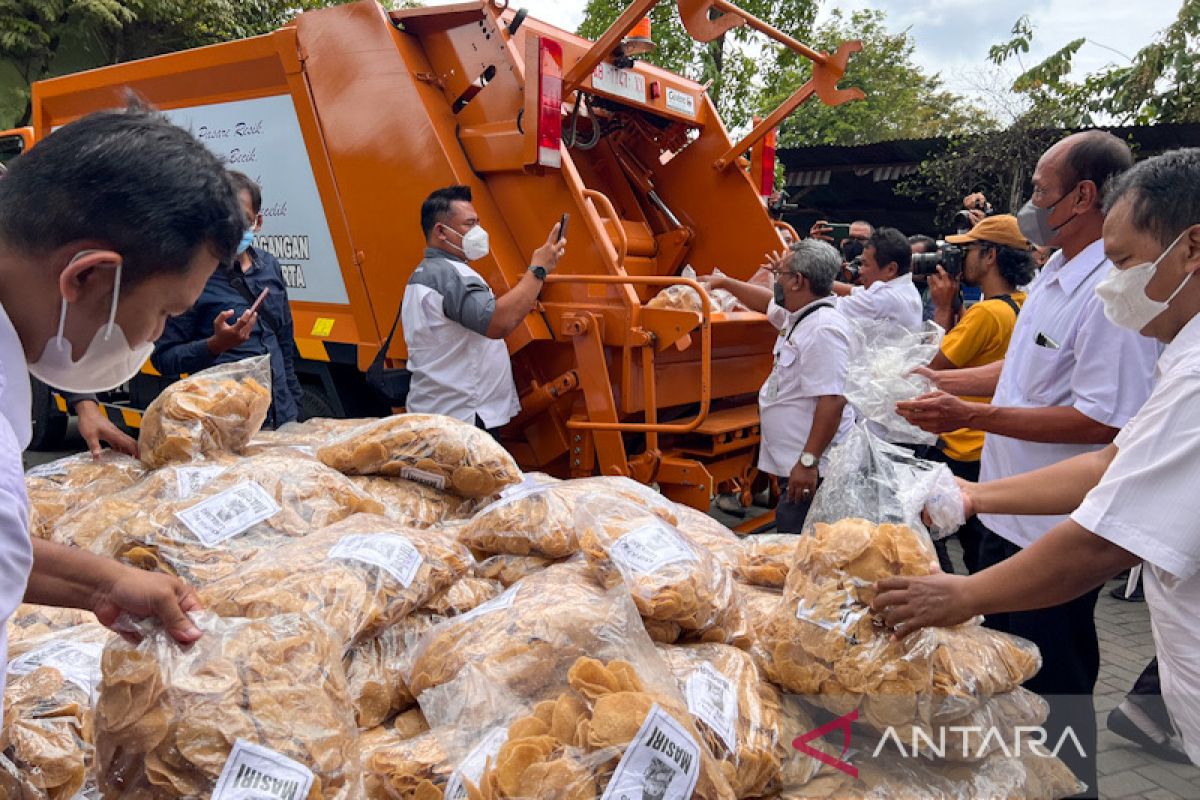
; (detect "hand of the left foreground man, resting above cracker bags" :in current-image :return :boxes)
[91,564,200,644]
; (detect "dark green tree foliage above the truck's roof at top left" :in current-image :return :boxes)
[0,0,357,125]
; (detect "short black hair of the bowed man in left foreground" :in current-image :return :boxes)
[0,102,245,285]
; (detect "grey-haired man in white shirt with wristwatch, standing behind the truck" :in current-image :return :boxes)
[758,239,853,534]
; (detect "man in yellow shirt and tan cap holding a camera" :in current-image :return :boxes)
[929,213,1036,572]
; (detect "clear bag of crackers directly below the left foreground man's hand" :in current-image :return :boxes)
[96,612,362,800]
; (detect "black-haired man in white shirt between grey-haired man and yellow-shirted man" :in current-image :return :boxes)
[833,228,923,331]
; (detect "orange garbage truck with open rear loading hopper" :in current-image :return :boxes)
[8,0,860,509]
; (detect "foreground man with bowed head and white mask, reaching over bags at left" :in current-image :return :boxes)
[0,108,242,710]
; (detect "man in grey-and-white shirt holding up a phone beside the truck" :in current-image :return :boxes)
[401,186,566,432]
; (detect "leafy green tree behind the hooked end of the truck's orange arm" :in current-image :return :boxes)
[758,8,995,148]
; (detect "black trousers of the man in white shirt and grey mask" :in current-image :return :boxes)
[979,529,1100,798]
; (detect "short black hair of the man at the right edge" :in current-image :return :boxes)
[1104,148,1200,247]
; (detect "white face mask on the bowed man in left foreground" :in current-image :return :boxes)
[29,251,154,395]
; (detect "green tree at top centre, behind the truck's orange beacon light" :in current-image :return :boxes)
[578,0,817,128]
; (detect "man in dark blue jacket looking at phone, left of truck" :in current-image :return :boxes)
[150,170,301,428]
